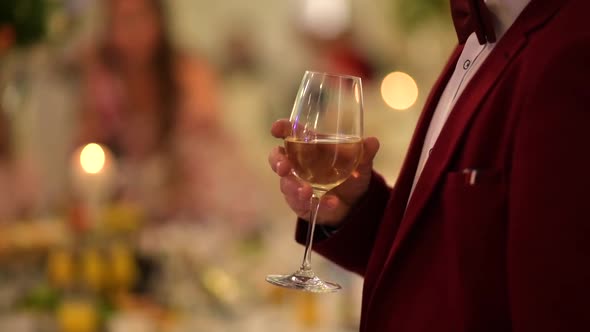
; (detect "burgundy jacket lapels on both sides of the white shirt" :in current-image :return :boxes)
[370,0,564,304]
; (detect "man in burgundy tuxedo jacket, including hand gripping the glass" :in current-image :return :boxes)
[269,0,590,332]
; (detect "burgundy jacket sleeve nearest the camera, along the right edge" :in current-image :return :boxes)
[507,41,590,332]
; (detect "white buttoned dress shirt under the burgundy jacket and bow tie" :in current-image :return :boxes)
[410,0,530,197]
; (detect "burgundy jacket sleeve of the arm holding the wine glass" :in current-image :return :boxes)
[295,172,391,276]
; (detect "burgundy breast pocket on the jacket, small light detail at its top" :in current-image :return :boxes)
[441,169,507,331]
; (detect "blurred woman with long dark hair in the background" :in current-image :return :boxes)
[80,0,252,223]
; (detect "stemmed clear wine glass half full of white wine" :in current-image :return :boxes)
[266,71,363,293]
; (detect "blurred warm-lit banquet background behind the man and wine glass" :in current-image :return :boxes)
[0,0,456,332]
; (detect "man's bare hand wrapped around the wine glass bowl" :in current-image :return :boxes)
[268,120,379,226]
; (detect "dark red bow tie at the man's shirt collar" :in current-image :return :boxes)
[451,0,496,45]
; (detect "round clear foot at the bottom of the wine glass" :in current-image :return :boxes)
[266,270,342,293]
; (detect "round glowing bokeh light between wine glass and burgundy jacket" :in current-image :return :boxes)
[381,71,418,111]
